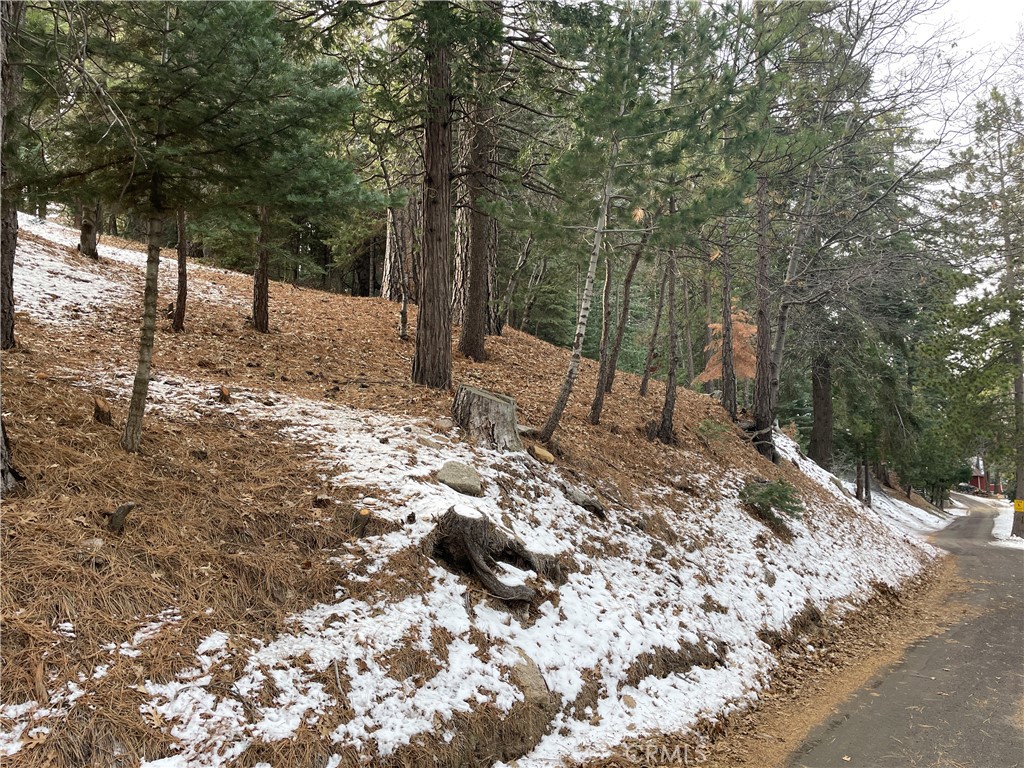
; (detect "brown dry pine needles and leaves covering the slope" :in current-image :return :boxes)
[0,231,892,768]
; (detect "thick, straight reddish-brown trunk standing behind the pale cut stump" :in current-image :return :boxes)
[413,1,452,389]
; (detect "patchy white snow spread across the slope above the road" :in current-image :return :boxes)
[0,225,934,768]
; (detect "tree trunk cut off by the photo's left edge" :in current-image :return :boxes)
[0,0,26,349]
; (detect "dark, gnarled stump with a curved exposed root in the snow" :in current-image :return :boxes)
[431,507,557,601]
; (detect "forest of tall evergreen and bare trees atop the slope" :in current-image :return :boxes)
[3,2,1024,501]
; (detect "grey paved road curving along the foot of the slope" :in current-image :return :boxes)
[787,502,1024,768]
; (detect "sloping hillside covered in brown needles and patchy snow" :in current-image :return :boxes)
[0,219,935,768]
